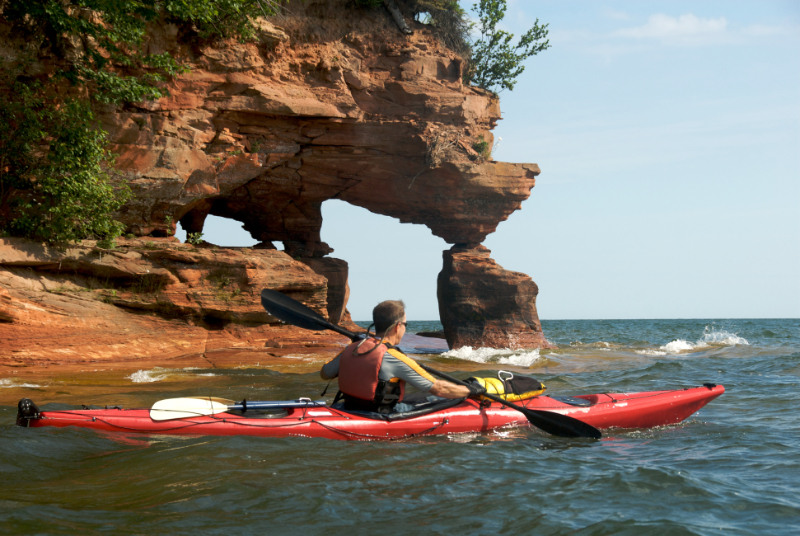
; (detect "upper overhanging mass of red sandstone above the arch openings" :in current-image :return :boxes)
[95,0,539,253]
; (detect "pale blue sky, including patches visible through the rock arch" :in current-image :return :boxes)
[184,0,800,320]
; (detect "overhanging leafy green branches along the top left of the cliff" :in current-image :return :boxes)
[2,0,279,104]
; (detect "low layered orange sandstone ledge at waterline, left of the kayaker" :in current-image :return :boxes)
[0,238,355,366]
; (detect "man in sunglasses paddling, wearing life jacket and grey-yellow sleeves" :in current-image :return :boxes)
[320,300,486,413]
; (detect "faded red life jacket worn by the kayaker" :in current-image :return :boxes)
[339,339,406,406]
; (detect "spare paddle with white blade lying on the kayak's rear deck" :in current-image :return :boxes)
[150,397,325,421]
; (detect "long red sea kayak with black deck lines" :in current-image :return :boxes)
[17,384,725,440]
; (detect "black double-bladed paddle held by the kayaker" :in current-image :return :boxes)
[261,289,602,439]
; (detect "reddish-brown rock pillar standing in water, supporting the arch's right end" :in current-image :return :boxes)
[438,246,554,349]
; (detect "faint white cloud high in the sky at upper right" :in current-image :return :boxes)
[614,13,728,44]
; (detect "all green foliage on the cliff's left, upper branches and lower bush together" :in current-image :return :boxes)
[0,0,279,242]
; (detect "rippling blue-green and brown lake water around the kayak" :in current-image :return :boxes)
[0,319,800,535]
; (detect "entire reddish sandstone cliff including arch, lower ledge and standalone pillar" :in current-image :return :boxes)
[0,0,546,368]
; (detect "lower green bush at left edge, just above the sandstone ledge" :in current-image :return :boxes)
[0,84,129,243]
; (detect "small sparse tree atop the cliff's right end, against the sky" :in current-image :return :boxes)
[465,0,550,92]
